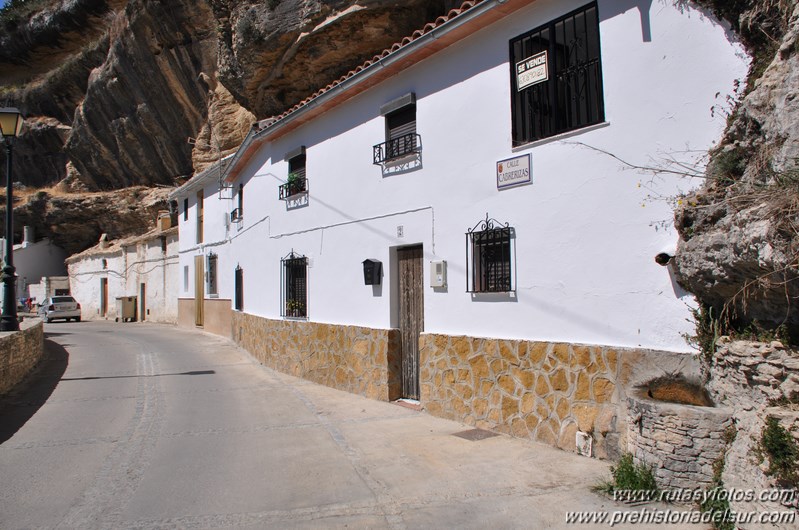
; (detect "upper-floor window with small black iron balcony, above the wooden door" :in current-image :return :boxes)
[372,93,422,164]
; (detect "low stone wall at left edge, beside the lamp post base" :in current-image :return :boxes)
[0,319,44,394]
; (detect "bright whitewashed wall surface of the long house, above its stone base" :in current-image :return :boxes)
[175,0,748,351]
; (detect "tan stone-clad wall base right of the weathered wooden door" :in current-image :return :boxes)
[420,334,626,458]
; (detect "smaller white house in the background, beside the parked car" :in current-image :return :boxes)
[67,215,179,324]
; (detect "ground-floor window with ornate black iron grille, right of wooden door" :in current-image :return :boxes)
[466,215,515,293]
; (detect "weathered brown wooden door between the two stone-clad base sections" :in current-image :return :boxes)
[397,246,424,399]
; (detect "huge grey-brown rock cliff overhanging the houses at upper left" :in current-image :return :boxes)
[0,0,460,248]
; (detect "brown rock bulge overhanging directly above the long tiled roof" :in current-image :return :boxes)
[209,0,450,118]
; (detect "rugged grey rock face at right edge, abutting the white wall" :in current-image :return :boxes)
[675,0,799,325]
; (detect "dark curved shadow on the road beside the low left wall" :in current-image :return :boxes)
[0,334,69,444]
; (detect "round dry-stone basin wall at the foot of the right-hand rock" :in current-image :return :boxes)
[627,397,732,489]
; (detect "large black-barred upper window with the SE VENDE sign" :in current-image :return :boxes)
[510,2,605,145]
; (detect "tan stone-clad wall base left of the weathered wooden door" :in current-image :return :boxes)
[232,311,400,401]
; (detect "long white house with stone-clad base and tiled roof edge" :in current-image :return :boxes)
[172,0,748,451]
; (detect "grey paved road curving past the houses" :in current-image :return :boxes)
[0,322,676,529]
